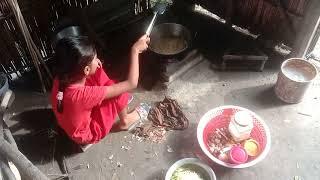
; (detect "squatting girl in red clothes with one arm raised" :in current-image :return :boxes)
[51,35,150,148]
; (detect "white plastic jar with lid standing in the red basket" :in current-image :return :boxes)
[229,111,253,142]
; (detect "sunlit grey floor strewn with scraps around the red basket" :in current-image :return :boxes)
[3,61,320,180]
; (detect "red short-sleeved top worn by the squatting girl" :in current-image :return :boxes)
[51,79,106,144]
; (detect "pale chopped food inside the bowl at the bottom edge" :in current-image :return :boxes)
[170,164,210,180]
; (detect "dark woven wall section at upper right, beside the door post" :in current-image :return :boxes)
[193,0,310,45]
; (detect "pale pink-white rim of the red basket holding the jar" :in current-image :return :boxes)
[197,105,271,168]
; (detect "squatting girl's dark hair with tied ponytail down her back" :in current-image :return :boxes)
[55,36,97,113]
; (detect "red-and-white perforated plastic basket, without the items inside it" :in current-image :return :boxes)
[197,106,271,168]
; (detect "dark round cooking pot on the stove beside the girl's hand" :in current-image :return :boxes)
[149,23,192,57]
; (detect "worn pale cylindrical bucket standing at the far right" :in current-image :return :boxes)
[275,58,318,103]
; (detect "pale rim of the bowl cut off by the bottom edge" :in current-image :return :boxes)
[165,158,217,180]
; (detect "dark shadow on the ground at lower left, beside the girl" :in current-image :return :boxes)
[9,109,78,164]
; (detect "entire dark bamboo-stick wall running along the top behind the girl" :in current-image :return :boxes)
[0,0,320,81]
